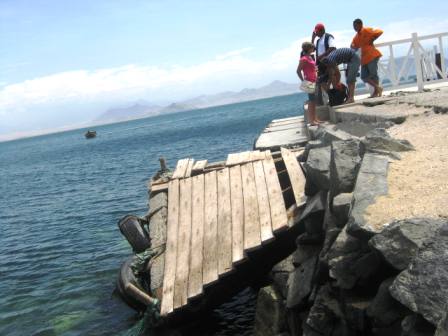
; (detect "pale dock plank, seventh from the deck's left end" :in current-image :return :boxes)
[241,163,261,251]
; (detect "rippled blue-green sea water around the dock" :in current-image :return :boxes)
[0,94,305,335]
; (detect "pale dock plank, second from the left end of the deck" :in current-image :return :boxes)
[174,178,191,309]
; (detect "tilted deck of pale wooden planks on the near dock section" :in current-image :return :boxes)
[158,149,305,317]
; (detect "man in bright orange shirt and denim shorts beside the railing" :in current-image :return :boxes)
[351,19,383,97]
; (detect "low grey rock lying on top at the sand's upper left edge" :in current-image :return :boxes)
[361,128,414,152]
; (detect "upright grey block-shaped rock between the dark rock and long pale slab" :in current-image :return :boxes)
[330,139,361,197]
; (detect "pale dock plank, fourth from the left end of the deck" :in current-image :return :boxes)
[202,171,218,285]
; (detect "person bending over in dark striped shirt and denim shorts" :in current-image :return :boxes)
[321,48,361,104]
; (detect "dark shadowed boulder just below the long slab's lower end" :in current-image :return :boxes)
[327,227,377,289]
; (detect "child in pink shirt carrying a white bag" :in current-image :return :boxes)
[297,42,321,126]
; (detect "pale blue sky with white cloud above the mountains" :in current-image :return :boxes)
[0,0,448,139]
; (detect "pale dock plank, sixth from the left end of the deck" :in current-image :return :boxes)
[230,166,244,264]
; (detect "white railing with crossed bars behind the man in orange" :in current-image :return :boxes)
[375,32,448,91]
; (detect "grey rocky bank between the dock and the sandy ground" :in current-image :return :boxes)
[255,91,448,336]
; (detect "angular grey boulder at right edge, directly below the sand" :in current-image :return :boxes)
[369,218,444,271]
